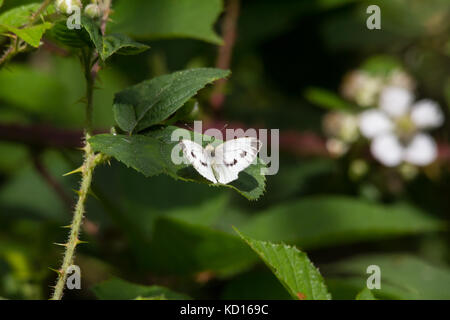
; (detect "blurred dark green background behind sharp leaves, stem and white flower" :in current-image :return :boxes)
[0,0,450,299]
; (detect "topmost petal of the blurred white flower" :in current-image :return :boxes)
[379,87,414,118]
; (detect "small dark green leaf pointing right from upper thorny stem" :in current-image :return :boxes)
[101,34,150,60]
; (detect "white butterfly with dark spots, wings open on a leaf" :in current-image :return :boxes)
[180,137,261,184]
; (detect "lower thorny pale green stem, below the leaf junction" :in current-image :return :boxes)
[51,138,103,300]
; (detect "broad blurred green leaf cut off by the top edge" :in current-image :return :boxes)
[112,0,223,44]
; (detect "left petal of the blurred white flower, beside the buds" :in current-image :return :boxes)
[358,109,393,139]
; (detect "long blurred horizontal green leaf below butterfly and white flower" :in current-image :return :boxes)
[240,196,443,249]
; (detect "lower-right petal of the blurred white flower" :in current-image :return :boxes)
[404,133,437,166]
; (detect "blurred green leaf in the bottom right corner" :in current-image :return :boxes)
[324,254,450,300]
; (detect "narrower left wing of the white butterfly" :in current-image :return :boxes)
[180,139,217,183]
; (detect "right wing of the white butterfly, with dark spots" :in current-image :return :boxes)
[212,137,261,184]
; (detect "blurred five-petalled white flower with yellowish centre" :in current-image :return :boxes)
[359,87,444,167]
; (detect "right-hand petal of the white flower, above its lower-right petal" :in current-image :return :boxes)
[411,99,444,129]
